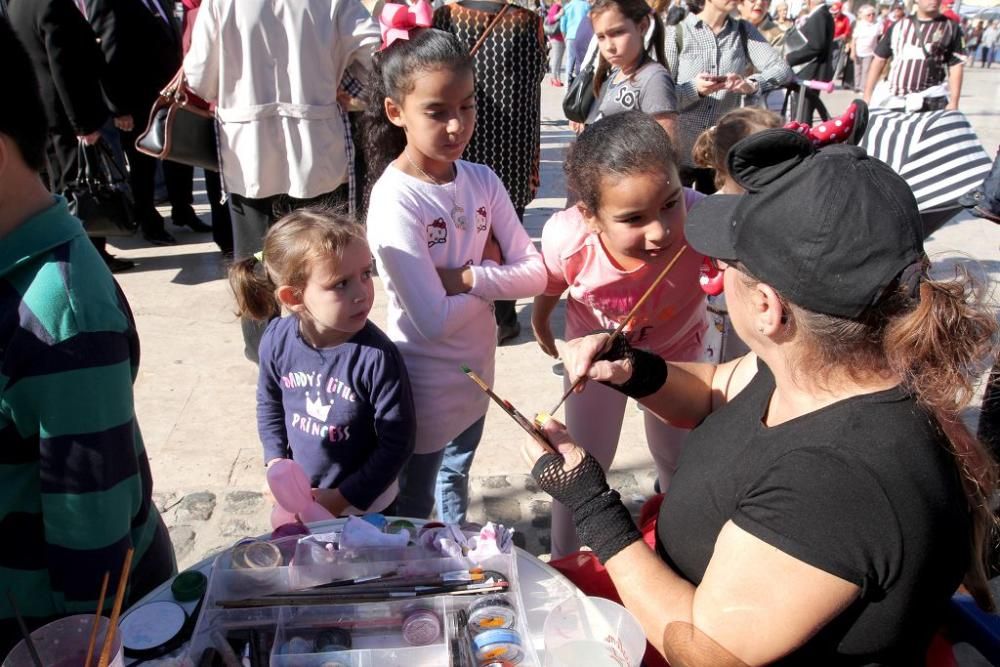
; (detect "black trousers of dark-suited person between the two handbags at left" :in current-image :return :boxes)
[120,125,194,234]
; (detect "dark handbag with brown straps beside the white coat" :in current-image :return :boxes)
[135,70,219,171]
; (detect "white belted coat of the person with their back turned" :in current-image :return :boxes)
[184,0,381,199]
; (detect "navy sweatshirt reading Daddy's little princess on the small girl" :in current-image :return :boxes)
[257,317,416,509]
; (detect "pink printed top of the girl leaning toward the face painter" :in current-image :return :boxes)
[542,189,708,361]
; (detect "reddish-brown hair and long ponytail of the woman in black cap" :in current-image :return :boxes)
[791,258,997,610]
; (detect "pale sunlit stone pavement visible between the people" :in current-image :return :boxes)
[112,69,1000,568]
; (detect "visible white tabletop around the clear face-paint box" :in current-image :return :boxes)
[126,517,580,665]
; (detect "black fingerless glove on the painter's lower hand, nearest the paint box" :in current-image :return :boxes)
[531,453,642,563]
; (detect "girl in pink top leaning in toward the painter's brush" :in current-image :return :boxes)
[532,112,718,558]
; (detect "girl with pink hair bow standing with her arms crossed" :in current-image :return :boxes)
[366,18,545,523]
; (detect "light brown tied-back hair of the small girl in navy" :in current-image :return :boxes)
[229,207,366,320]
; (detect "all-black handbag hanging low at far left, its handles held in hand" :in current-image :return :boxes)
[63,139,139,237]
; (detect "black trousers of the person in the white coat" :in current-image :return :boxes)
[229,184,348,363]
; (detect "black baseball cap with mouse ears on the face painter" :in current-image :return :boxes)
[684,129,924,319]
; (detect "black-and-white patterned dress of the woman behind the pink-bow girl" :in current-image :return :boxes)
[434,0,547,212]
